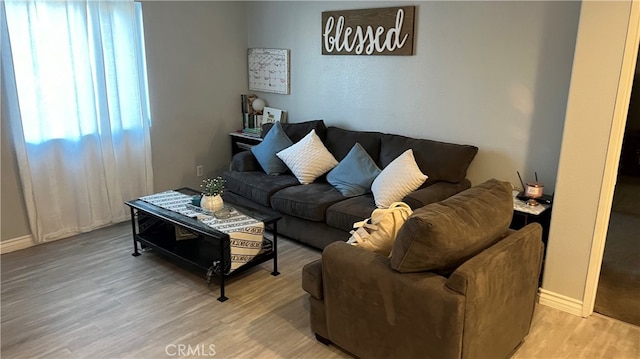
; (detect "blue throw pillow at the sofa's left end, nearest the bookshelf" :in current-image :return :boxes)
[251,122,293,175]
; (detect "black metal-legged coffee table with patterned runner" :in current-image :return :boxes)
[125,188,282,302]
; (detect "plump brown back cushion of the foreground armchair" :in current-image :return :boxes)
[391,179,513,273]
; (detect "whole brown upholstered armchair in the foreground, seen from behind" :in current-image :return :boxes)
[302,180,543,358]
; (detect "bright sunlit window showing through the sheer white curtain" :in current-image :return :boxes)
[5,1,150,144]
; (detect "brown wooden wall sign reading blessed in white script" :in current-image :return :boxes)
[322,6,415,55]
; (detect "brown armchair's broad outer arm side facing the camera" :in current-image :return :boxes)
[322,242,464,358]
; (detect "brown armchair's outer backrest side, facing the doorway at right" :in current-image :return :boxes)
[447,223,543,358]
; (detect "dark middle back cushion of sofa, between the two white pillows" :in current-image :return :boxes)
[324,126,382,163]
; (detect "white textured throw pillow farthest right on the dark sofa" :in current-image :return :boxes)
[371,149,427,208]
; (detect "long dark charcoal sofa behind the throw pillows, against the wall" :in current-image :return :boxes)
[223,120,478,249]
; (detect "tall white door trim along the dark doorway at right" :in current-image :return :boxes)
[581,0,640,317]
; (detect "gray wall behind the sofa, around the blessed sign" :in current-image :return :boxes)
[248,1,580,192]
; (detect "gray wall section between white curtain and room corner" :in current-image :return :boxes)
[143,1,247,191]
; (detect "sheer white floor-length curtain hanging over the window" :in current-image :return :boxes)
[2,0,153,242]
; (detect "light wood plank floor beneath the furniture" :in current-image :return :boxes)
[0,223,640,358]
